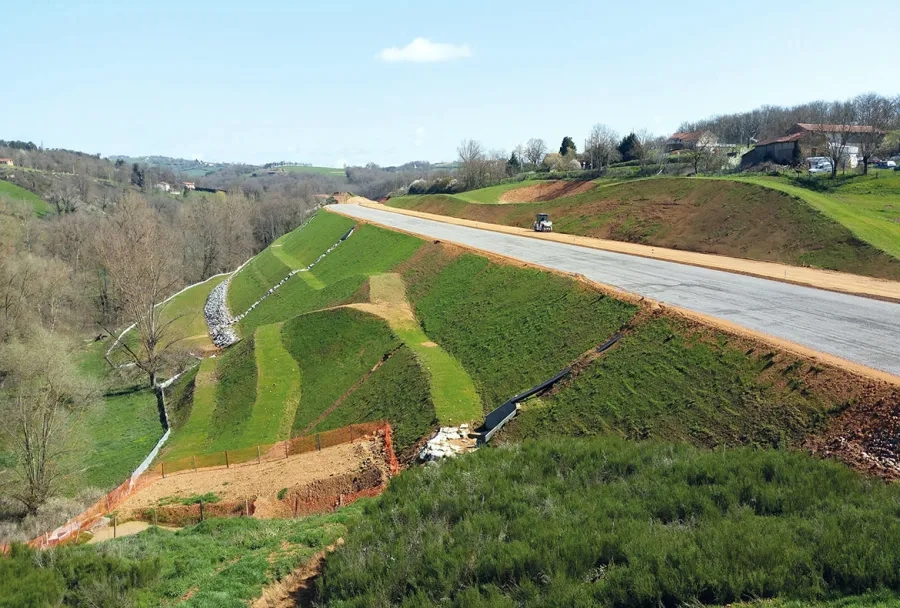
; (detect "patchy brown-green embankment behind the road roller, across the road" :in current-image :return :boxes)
[388,178,900,280]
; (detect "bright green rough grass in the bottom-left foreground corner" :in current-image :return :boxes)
[0,501,365,608]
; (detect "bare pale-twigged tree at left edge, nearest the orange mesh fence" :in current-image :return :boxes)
[0,330,96,514]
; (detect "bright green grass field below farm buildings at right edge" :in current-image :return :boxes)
[739,171,900,258]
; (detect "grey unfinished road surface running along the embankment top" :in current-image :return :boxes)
[341,205,900,376]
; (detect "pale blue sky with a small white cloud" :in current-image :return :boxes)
[0,0,900,166]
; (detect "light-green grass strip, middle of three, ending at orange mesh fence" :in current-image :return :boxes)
[242,324,300,445]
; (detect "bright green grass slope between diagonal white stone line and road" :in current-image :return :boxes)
[232,223,422,335]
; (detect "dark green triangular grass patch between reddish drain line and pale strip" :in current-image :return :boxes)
[313,346,438,451]
